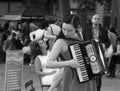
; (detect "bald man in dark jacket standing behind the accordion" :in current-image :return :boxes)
[84,14,110,91]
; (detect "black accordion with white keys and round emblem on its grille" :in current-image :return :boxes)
[69,40,107,83]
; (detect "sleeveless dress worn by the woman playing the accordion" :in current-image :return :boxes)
[62,39,97,91]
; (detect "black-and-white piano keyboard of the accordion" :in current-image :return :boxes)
[70,44,89,82]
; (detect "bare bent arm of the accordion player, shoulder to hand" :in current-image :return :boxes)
[46,39,80,68]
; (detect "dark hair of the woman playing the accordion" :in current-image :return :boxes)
[57,14,80,39]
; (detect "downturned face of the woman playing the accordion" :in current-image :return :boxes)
[62,23,76,38]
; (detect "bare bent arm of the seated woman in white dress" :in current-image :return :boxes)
[35,57,56,76]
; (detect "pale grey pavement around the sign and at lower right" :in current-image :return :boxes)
[0,64,120,91]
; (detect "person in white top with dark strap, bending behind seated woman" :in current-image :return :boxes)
[30,20,61,50]
